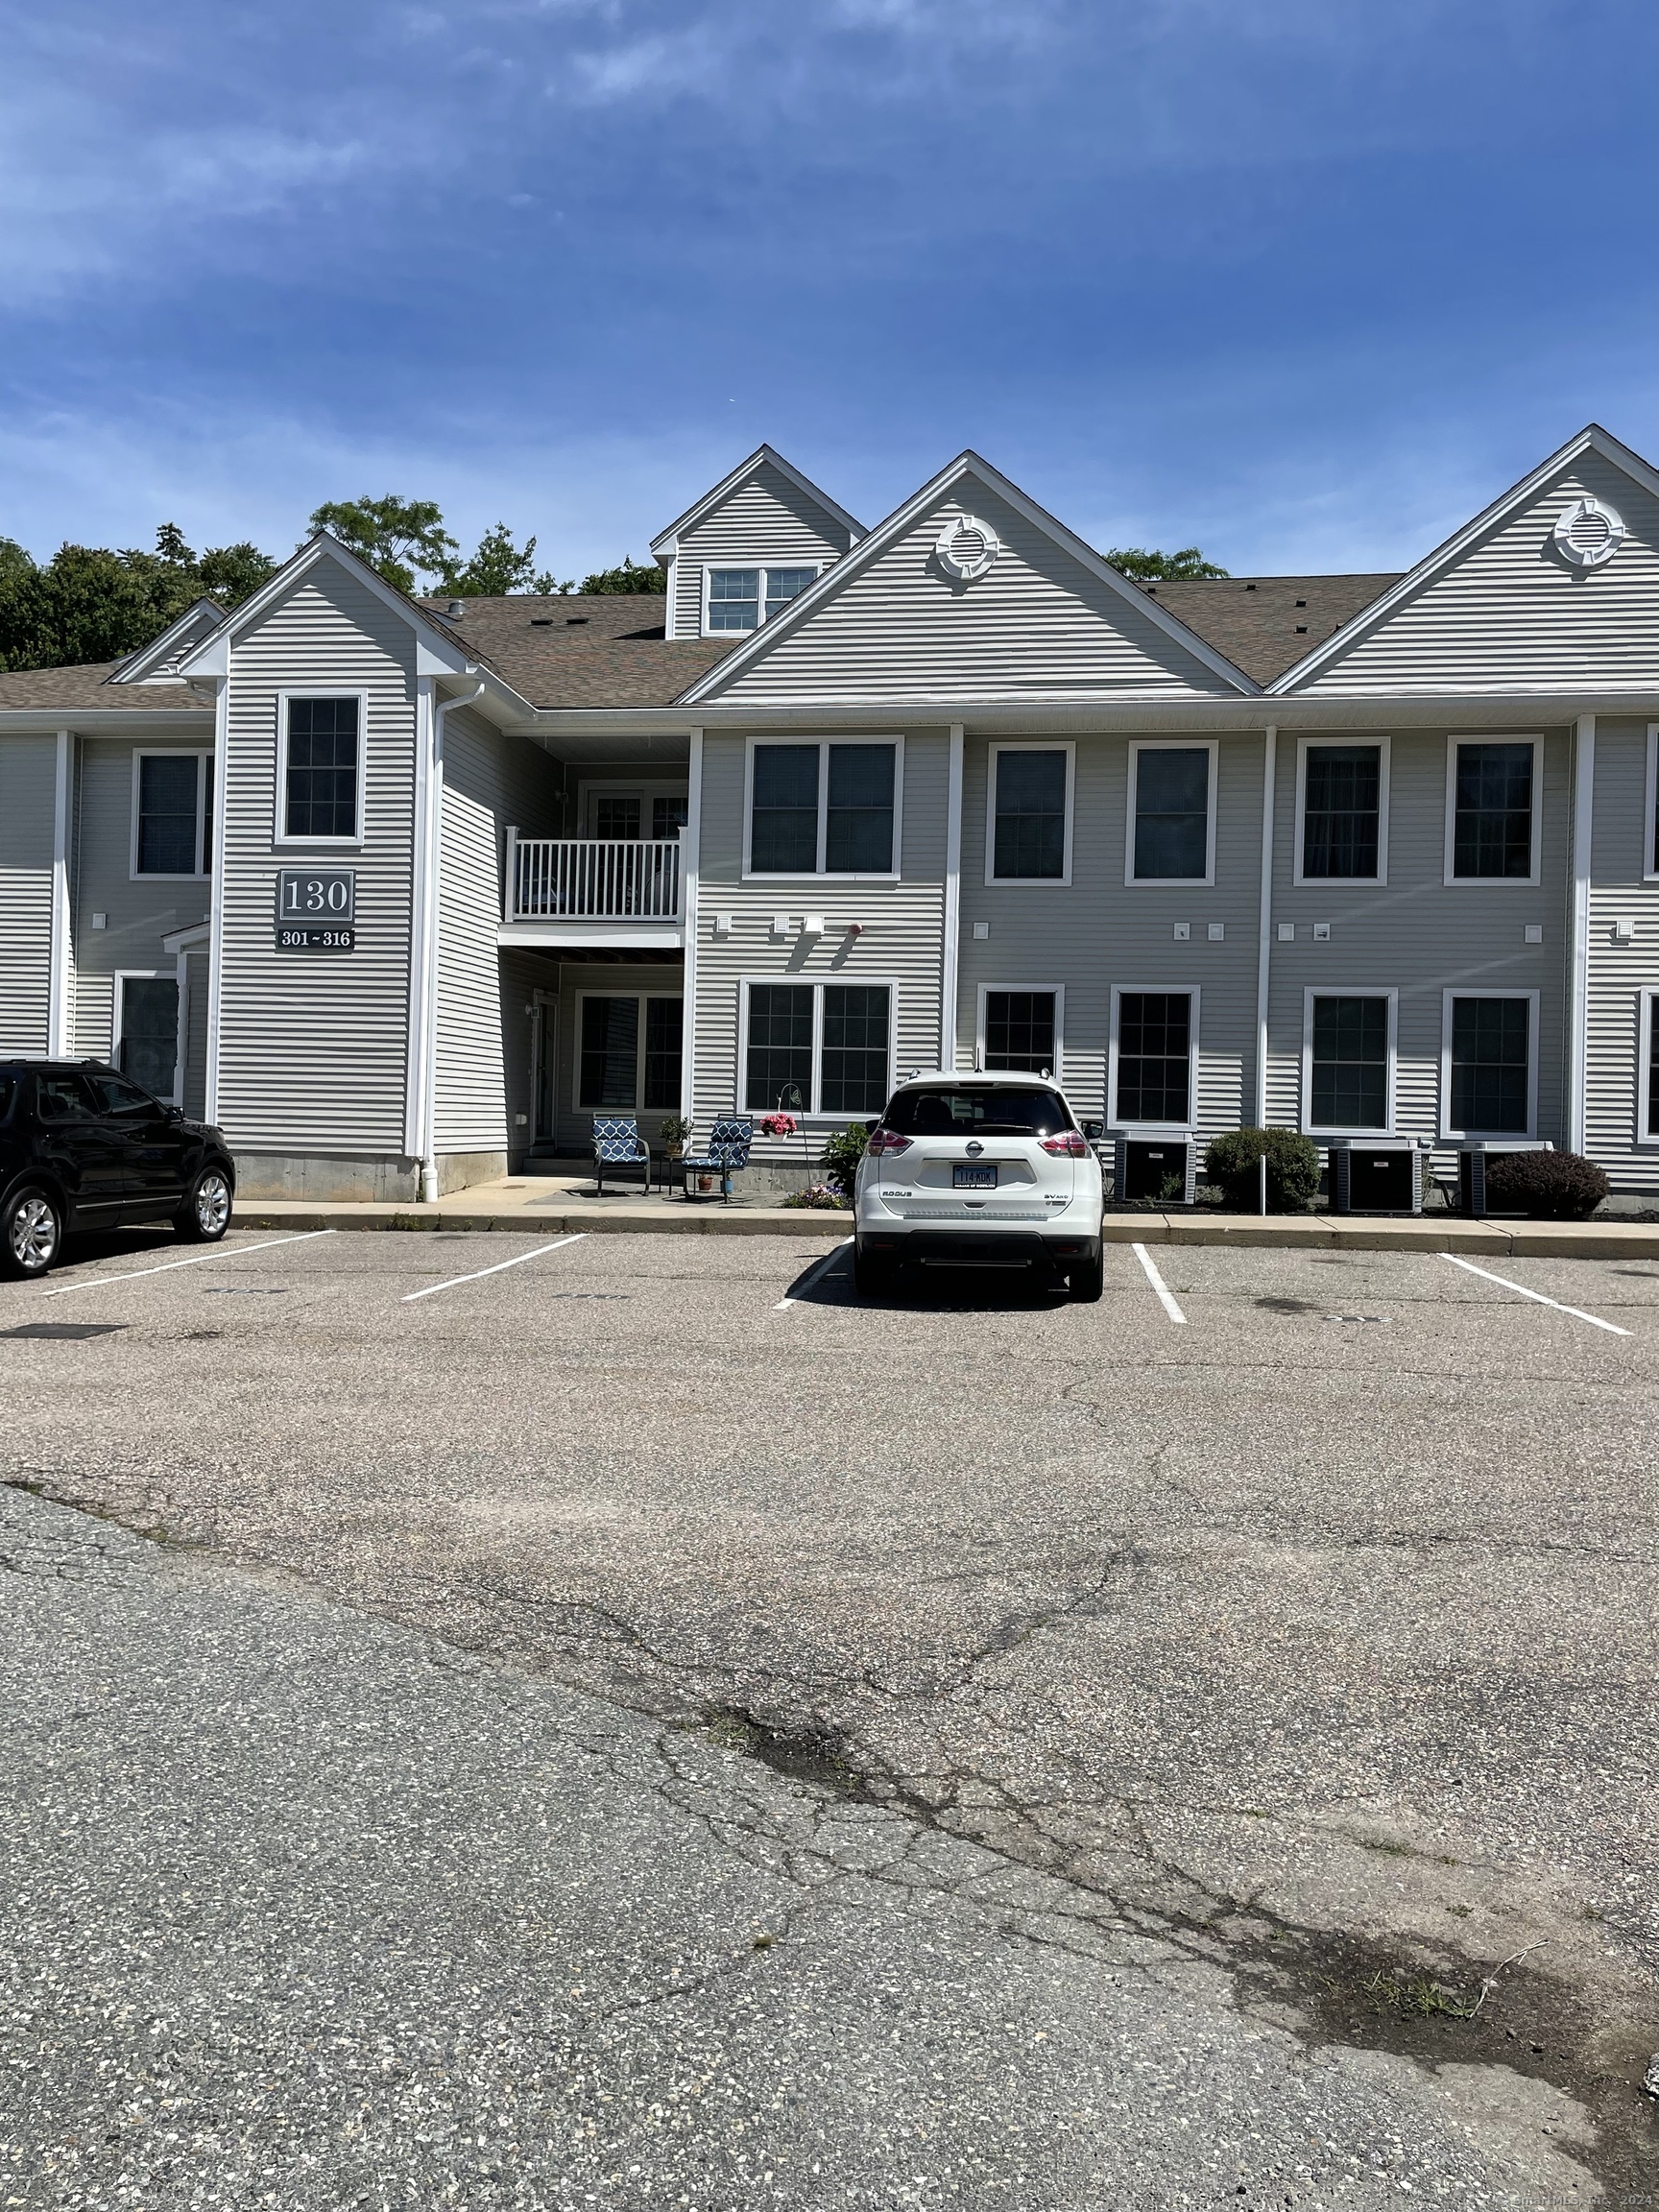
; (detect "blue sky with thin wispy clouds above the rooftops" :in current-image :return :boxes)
[0,0,1659,575]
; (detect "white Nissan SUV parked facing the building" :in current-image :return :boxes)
[852,1075,1104,1301]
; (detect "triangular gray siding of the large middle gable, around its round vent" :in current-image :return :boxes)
[719,487,1238,706]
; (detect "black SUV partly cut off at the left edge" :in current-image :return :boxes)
[0,1060,237,1276]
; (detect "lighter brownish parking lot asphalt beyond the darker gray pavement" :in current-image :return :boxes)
[0,1235,1659,2207]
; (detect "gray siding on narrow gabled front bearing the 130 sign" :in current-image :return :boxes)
[219,562,416,1157]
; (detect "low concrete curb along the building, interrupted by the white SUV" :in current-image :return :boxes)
[224,1199,1659,1259]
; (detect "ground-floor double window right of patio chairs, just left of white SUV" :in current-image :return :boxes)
[743,982,894,1115]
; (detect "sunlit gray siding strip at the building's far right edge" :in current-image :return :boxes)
[1584,721,1659,1192]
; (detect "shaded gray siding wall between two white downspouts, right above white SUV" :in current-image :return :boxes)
[955,733,1261,1137]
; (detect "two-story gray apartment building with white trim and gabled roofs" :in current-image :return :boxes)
[0,427,1659,1196]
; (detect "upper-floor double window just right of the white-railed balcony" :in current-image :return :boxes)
[748,736,902,876]
